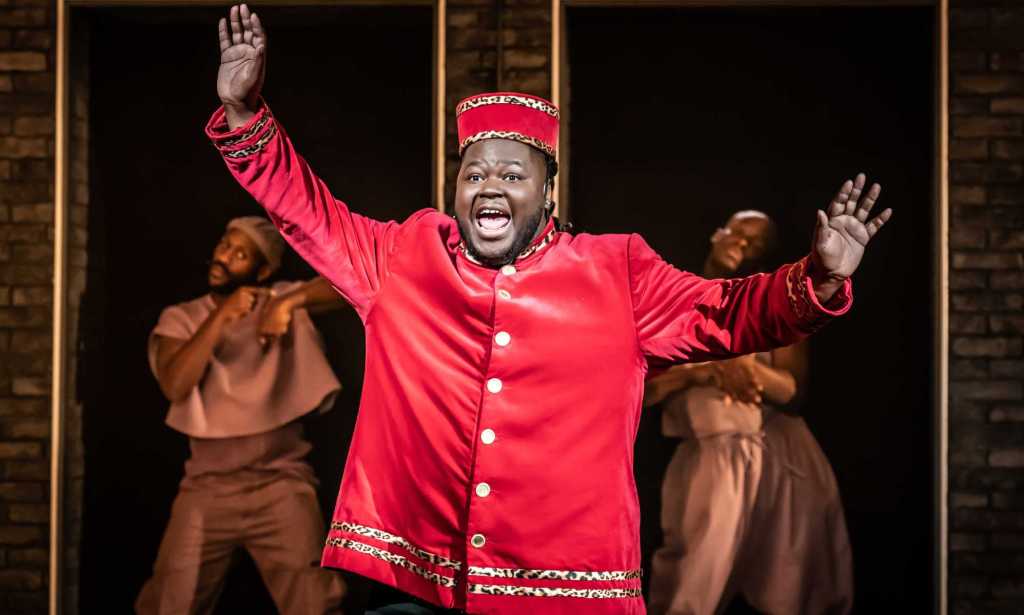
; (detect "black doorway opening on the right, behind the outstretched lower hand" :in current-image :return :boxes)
[566,8,937,613]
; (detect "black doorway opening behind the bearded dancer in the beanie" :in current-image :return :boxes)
[74,5,433,613]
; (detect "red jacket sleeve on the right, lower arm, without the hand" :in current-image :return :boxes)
[628,235,853,363]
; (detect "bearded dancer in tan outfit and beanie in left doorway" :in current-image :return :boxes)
[135,217,345,615]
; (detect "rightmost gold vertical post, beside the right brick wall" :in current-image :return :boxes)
[936,0,949,615]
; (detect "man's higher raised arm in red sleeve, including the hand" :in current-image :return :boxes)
[207,4,399,317]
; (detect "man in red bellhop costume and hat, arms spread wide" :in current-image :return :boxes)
[207,5,890,615]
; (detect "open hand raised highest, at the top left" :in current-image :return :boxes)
[217,4,266,113]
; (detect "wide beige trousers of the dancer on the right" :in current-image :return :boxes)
[648,414,853,615]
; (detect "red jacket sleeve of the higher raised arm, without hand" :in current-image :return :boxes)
[206,103,400,318]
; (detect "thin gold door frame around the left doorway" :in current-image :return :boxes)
[48,0,447,615]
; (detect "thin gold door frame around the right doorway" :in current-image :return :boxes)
[551,0,949,615]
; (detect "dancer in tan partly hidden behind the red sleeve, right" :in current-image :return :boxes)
[644,211,853,615]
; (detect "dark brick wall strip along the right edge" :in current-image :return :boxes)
[949,1,1024,613]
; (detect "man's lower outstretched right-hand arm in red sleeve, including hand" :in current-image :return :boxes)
[629,175,892,363]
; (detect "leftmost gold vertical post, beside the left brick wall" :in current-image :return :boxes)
[48,0,70,615]
